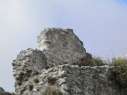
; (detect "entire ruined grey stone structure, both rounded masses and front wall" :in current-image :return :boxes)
[13,28,127,95]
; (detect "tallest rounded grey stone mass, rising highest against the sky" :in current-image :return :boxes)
[38,28,86,66]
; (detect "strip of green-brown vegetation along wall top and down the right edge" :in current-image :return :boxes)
[81,57,127,88]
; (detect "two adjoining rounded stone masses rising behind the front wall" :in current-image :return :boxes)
[13,28,86,92]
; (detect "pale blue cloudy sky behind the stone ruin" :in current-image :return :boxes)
[0,0,127,91]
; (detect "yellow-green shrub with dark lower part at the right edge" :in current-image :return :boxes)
[110,58,127,88]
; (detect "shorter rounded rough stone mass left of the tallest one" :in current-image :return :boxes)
[12,48,47,92]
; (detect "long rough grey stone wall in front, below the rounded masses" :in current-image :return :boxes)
[11,65,127,95]
